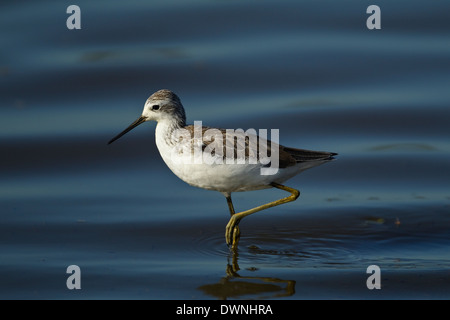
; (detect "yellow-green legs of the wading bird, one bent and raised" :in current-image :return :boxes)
[225,182,300,249]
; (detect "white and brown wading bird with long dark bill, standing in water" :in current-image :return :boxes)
[108,90,336,248]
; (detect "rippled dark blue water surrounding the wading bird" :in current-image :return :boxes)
[0,1,450,299]
